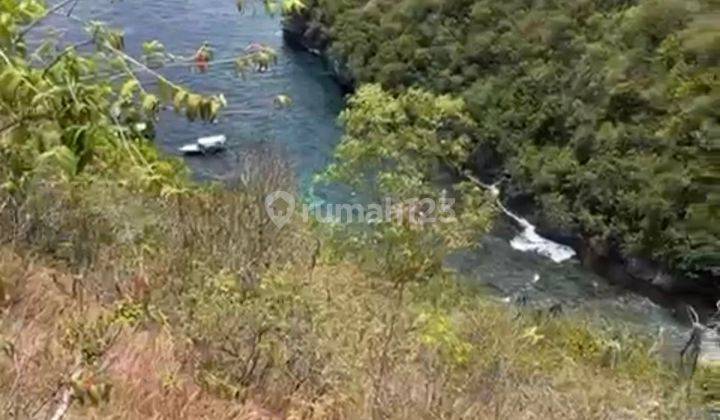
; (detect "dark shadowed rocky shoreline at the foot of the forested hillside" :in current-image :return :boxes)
[283,15,720,317]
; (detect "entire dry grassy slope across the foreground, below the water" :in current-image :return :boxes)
[0,150,704,420]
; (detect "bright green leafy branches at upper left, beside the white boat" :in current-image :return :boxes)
[0,0,299,200]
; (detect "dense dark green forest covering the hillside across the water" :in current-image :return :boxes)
[292,0,720,283]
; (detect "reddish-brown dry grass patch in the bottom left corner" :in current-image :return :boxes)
[0,248,286,419]
